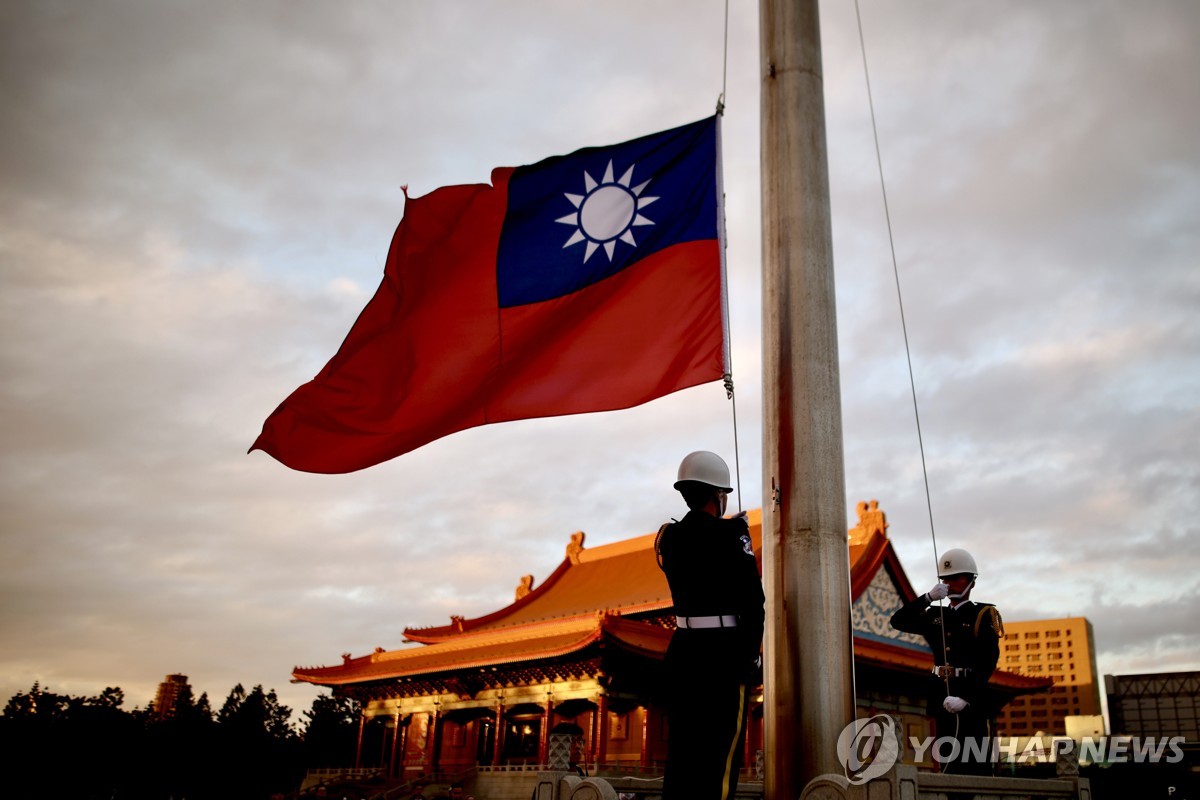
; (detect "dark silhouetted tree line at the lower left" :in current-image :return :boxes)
[0,684,360,800]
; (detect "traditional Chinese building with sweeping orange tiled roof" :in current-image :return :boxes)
[293,501,1050,776]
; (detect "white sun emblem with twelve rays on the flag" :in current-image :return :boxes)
[556,161,659,264]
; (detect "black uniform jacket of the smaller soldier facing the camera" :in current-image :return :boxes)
[892,595,1004,716]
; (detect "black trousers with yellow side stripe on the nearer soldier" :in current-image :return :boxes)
[662,631,751,800]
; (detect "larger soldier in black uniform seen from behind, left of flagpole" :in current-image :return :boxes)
[654,451,766,800]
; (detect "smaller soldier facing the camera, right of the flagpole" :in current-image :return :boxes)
[892,549,1004,775]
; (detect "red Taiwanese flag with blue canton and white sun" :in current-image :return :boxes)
[251,116,727,473]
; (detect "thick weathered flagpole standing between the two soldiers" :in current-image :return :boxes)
[760,0,854,800]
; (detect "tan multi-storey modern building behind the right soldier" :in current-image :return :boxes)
[996,616,1100,736]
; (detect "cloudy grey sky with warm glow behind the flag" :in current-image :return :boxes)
[0,0,1200,716]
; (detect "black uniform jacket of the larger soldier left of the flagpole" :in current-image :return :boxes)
[655,511,766,674]
